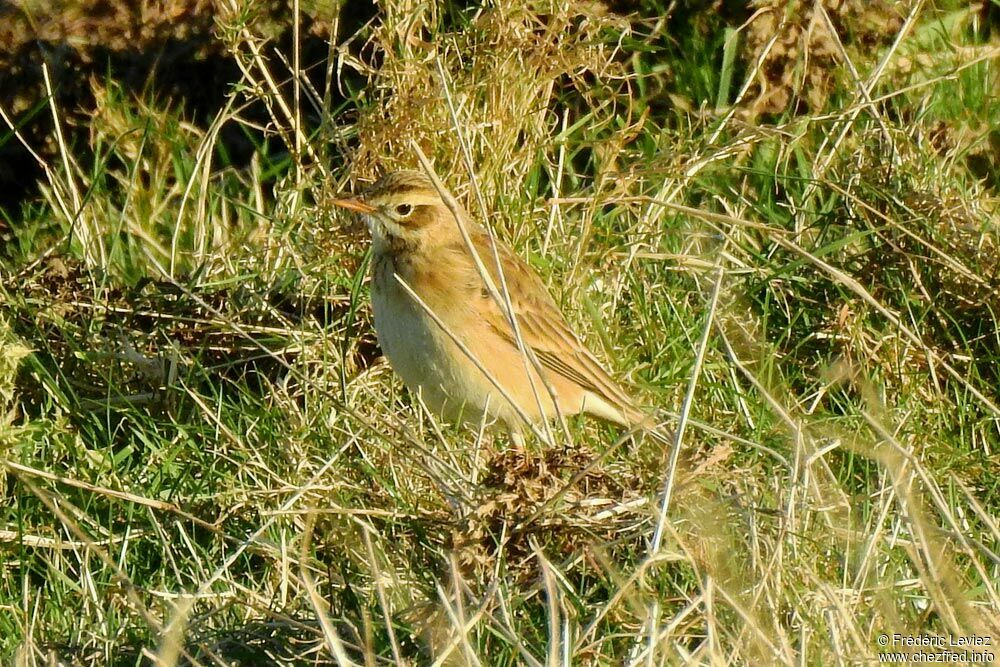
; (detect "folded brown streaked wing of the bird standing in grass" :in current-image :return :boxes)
[473,231,635,415]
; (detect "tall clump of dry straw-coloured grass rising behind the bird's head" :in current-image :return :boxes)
[352,3,628,196]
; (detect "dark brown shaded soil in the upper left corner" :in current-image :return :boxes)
[0,0,373,212]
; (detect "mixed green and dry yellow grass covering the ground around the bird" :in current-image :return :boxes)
[0,2,1000,665]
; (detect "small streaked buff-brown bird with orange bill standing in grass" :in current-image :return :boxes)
[332,170,664,442]
